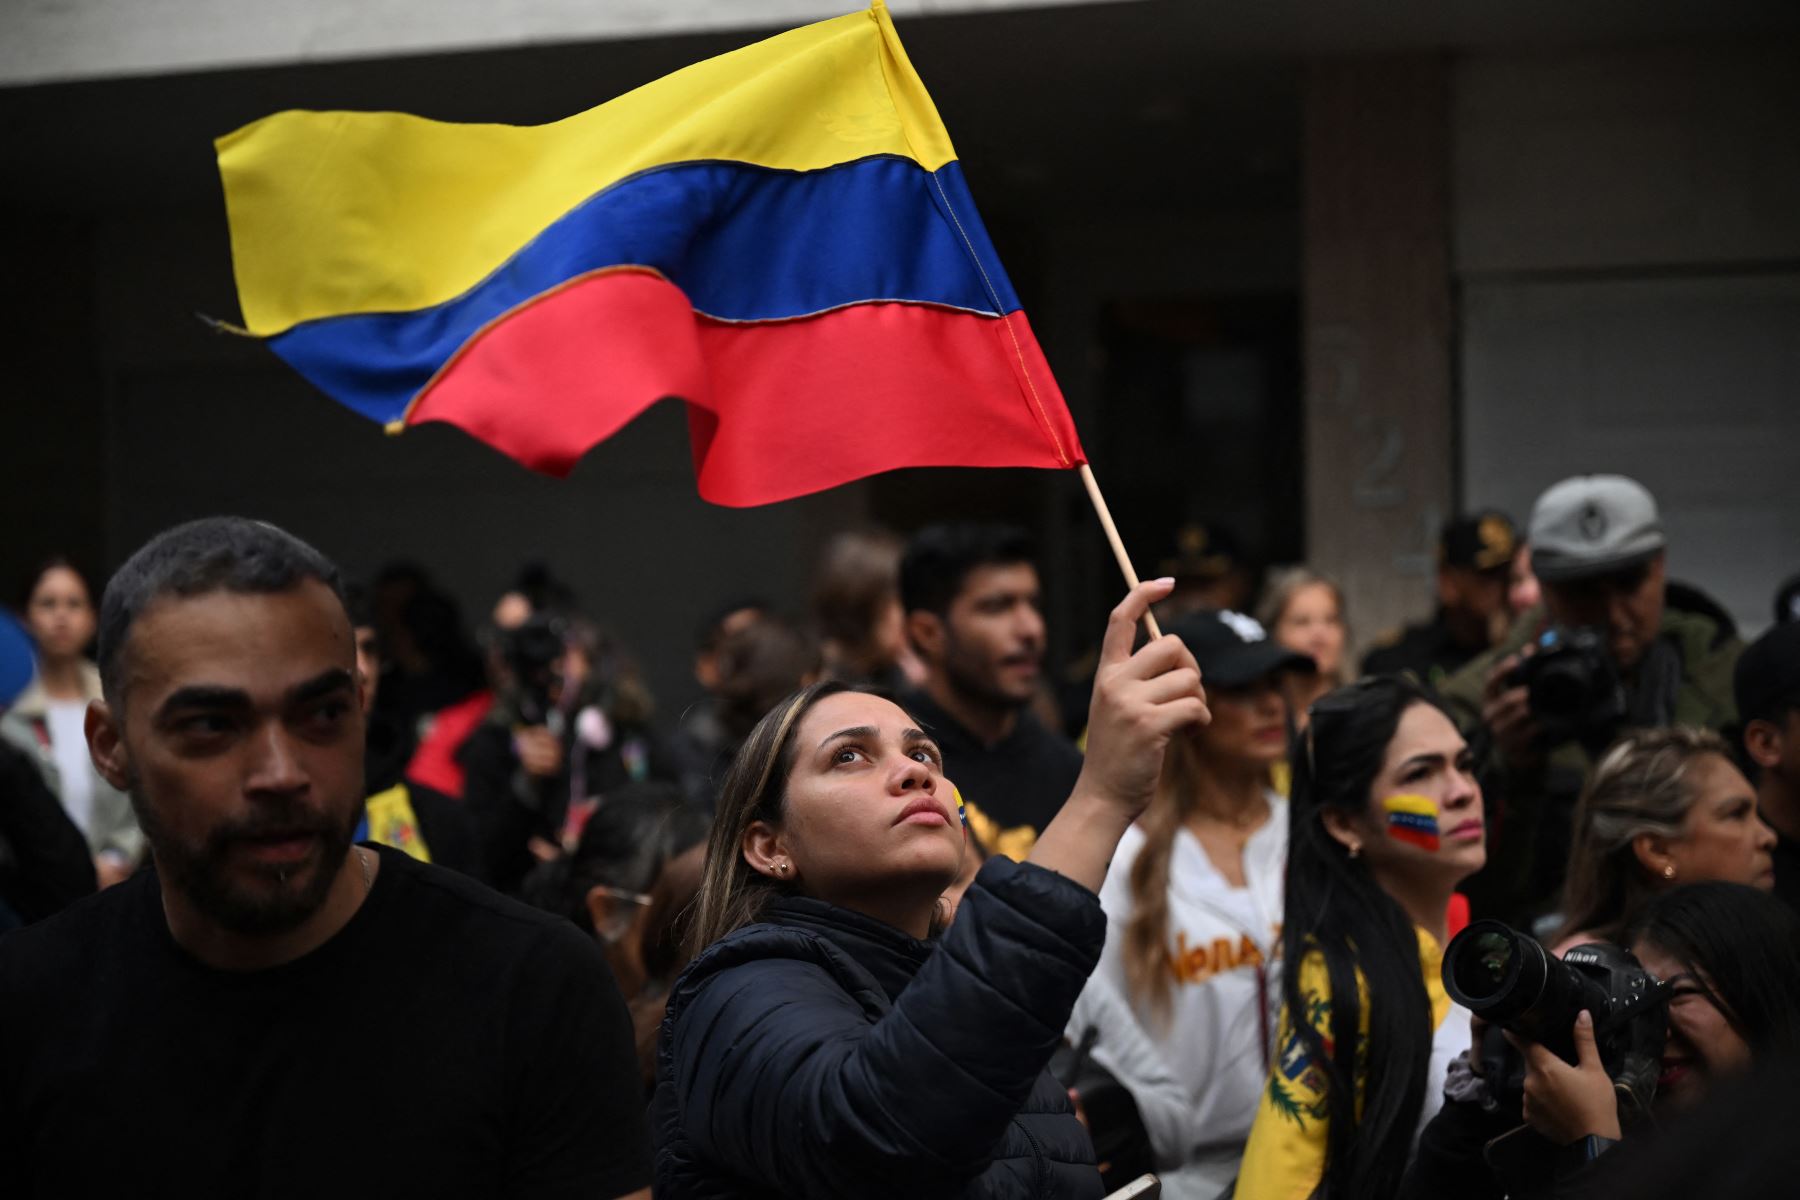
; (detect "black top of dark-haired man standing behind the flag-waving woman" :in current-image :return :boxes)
[902,693,1082,855]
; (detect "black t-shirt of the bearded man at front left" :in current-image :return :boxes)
[0,849,650,1200]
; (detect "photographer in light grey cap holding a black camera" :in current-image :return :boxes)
[1442,475,1742,921]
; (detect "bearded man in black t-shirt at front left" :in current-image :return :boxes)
[0,518,650,1196]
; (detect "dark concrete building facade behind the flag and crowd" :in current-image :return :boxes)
[0,0,1800,700]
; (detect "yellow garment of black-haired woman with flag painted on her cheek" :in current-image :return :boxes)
[1237,928,1451,1200]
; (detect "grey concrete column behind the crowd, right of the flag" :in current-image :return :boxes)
[1301,56,1454,648]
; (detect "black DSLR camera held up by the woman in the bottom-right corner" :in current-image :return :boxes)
[1444,921,1669,1110]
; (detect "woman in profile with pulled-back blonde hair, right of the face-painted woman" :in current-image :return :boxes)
[1555,727,1775,954]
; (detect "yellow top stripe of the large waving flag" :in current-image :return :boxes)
[216,0,956,336]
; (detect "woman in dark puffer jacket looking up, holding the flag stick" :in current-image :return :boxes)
[652,579,1210,1200]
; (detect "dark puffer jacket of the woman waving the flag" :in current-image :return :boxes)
[650,858,1105,1200]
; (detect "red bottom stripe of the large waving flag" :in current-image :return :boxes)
[407,270,1085,506]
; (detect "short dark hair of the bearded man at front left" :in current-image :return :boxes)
[97,516,344,705]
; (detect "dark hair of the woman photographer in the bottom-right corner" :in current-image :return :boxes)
[1625,882,1800,1061]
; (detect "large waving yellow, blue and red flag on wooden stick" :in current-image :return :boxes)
[218,0,1085,506]
